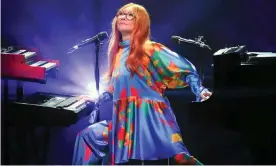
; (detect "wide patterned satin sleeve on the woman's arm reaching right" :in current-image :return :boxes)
[151,43,205,101]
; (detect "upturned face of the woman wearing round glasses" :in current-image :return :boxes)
[117,7,135,33]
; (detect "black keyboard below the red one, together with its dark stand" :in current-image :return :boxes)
[6,92,98,165]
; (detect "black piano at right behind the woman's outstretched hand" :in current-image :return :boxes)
[213,46,276,90]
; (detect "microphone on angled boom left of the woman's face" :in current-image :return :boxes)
[68,32,108,53]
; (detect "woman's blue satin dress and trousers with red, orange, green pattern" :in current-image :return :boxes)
[73,41,204,165]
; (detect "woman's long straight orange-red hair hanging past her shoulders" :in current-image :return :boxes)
[107,3,150,79]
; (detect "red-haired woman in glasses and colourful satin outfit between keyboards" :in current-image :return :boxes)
[73,3,211,164]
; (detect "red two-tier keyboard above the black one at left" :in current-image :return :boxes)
[1,46,59,100]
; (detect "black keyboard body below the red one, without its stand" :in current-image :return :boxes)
[10,92,94,126]
